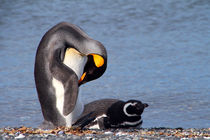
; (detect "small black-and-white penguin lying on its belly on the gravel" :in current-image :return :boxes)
[74,99,148,129]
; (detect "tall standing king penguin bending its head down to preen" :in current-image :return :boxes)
[34,22,107,129]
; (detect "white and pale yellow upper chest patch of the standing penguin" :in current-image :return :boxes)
[63,48,88,79]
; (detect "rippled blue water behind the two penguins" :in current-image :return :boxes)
[0,0,210,128]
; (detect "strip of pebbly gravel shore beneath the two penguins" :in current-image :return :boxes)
[0,126,210,140]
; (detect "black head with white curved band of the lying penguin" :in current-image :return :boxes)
[123,100,149,117]
